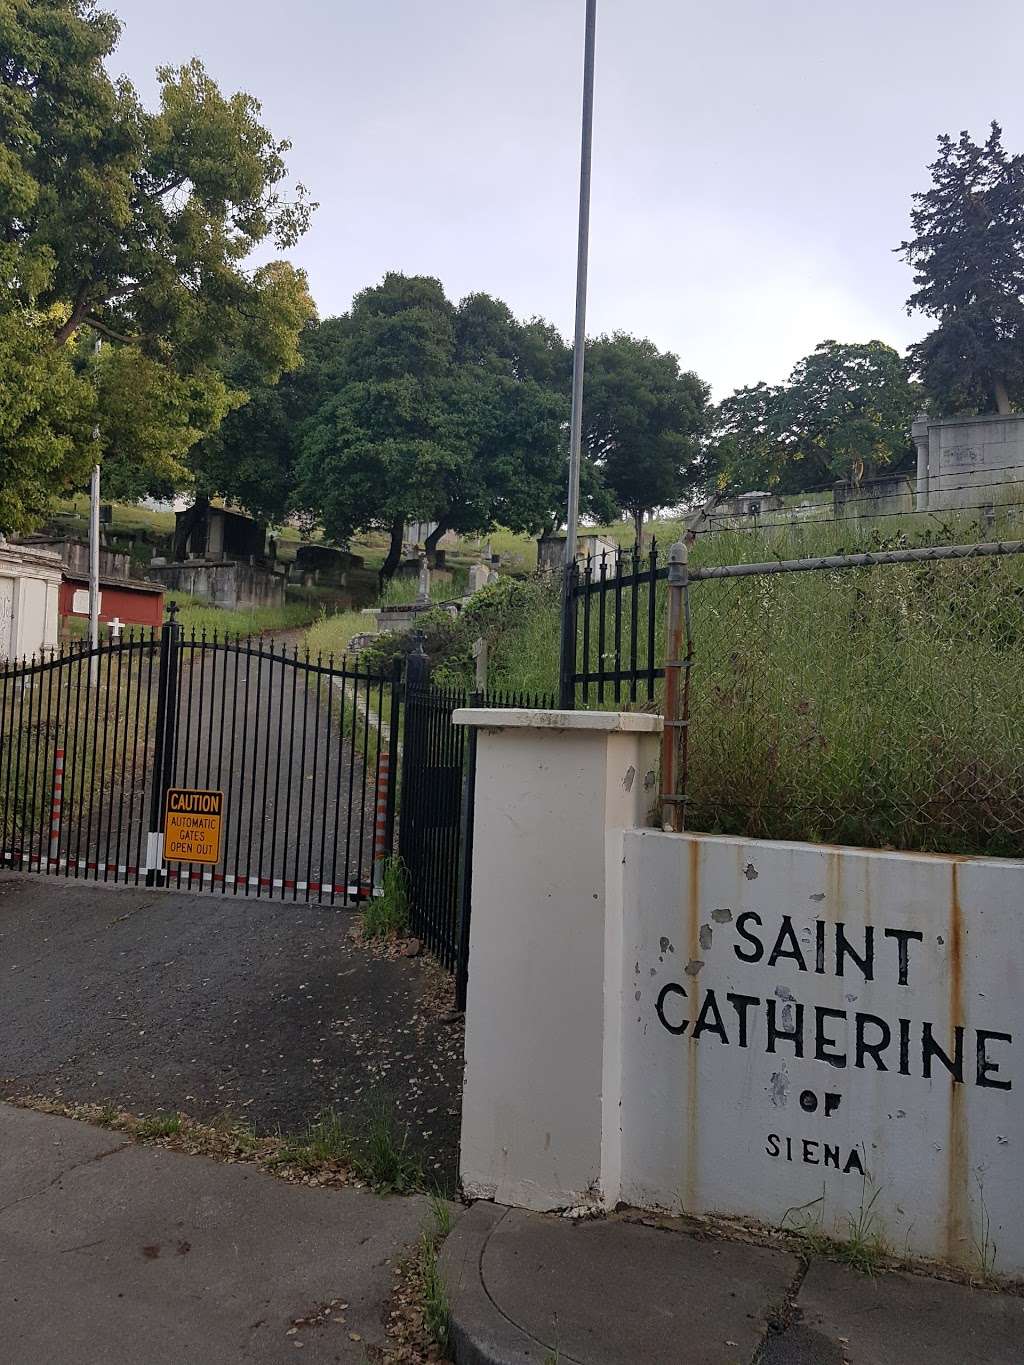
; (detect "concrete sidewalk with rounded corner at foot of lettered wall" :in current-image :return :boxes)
[442,1203,1024,1365]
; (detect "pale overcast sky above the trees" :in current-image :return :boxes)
[108,0,1024,397]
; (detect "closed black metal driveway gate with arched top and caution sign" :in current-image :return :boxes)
[0,612,400,905]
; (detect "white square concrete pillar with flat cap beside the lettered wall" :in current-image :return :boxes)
[455,710,661,1209]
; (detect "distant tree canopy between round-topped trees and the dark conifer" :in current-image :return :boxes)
[710,341,918,493]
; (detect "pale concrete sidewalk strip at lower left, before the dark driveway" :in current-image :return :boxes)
[0,1104,427,1365]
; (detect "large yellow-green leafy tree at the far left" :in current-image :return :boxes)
[0,0,313,520]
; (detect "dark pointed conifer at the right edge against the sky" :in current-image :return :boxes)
[897,123,1024,412]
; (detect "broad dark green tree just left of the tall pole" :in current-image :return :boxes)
[298,273,578,577]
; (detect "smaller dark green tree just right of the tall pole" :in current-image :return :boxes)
[583,332,710,543]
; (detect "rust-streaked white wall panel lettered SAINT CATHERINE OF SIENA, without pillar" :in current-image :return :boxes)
[617,830,1024,1272]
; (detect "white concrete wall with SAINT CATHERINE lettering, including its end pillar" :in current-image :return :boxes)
[456,711,1024,1275]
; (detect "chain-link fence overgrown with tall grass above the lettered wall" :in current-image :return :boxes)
[683,546,1024,856]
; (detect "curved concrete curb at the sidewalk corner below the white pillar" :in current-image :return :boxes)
[440,1200,550,1365]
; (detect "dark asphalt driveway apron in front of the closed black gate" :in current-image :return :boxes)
[0,872,463,1179]
